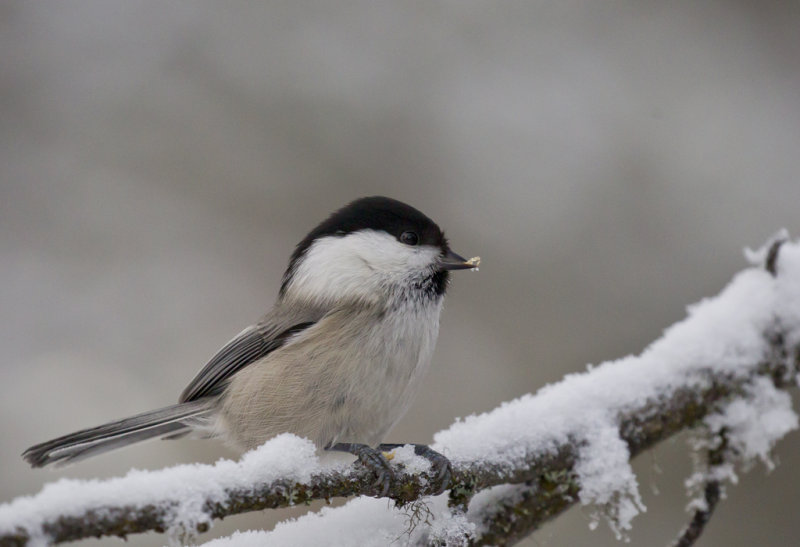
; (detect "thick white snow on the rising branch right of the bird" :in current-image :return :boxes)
[433,233,800,536]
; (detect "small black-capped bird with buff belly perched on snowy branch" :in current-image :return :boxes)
[22,197,480,494]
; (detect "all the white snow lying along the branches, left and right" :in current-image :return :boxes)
[0,238,800,547]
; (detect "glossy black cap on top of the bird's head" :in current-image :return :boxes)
[280,196,450,294]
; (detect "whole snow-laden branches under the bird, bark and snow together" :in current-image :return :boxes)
[0,234,800,547]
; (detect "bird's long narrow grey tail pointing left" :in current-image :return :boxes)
[22,399,212,467]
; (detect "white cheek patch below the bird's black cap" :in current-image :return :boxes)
[288,230,439,301]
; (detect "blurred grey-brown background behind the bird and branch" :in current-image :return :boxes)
[0,0,800,547]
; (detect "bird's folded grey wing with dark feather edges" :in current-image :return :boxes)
[179,309,325,403]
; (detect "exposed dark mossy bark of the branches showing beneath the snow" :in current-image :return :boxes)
[0,237,800,546]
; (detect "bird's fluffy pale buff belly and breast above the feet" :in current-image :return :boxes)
[218,302,438,449]
